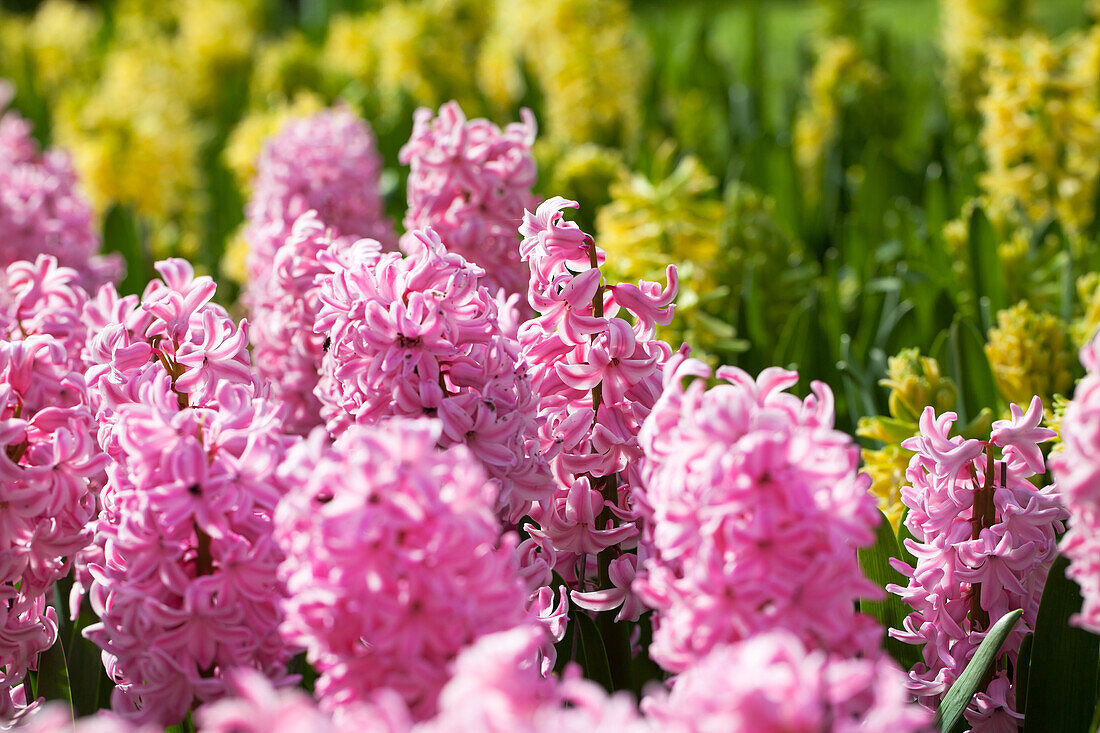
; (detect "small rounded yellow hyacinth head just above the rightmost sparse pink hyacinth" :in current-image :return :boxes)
[986,300,1076,408]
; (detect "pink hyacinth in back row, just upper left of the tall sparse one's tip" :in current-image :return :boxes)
[399,101,537,293]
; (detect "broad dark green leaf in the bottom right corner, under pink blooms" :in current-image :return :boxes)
[1024,555,1100,733]
